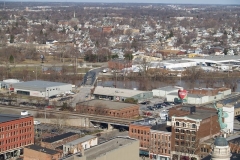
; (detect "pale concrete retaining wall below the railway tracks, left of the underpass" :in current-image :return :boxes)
[34,118,92,127]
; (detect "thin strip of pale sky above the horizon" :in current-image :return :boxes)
[0,0,240,4]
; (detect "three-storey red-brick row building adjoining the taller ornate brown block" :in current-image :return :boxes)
[129,119,171,160]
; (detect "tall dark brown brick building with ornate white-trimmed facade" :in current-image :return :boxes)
[167,105,220,160]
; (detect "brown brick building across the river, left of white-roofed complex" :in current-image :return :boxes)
[108,59,132,70]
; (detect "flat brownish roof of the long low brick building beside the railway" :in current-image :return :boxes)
[77,99,138,110]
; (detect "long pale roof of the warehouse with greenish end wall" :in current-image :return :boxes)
[94,86,152,97]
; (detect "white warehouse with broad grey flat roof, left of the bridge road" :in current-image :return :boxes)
[13,80,72,98]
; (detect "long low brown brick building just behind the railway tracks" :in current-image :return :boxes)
[76,99,139,118]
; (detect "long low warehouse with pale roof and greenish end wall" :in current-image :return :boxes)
[93,86,153,102]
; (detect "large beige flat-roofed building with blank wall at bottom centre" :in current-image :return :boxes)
[61,137,139,160]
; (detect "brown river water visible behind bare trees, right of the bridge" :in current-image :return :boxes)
[98,80,240,92]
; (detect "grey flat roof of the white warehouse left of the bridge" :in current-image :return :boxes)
[12,80,72,91]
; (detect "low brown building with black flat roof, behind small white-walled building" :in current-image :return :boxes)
[41,132,79,150]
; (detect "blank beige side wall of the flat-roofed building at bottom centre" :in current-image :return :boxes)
[95,141,139,160]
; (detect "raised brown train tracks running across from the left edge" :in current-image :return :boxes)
[0,105,134,125]
